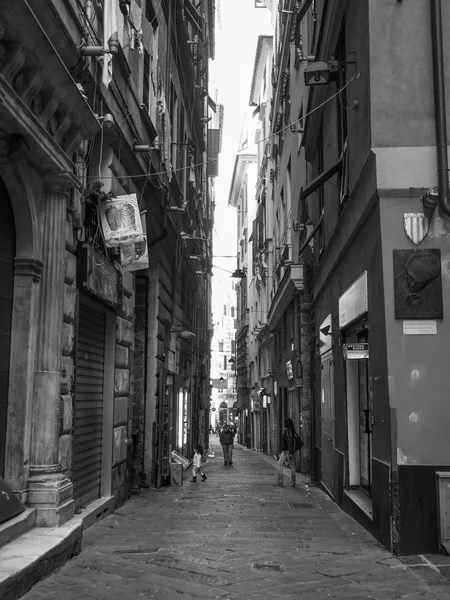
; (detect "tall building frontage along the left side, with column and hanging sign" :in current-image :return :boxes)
[0,0,218,584]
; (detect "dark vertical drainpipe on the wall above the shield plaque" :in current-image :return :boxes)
[430,0,450,216]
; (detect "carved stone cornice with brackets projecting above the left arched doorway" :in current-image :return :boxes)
[0,6,100,171]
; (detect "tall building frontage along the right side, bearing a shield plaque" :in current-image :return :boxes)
[243,0,450,554]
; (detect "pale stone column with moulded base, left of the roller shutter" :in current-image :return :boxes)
[28,173,74,527]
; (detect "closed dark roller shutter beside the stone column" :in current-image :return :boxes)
[73,305,105,507]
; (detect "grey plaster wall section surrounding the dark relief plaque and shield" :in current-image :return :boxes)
[381,197,450,465]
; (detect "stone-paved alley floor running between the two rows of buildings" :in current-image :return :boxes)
[19,436,450,600]
